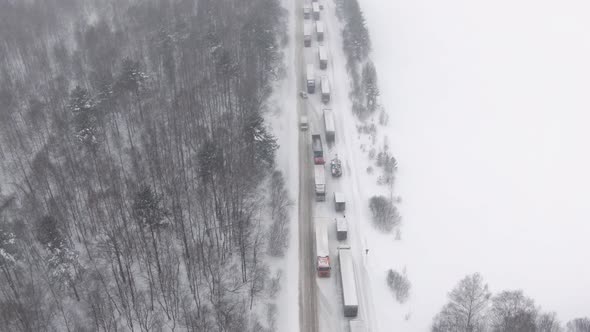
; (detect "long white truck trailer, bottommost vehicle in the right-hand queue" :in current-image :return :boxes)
[338,247,359,317]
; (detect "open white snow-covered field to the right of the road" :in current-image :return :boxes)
[360,0,590,331]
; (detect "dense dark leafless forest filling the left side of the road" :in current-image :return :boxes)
[0,0,288,331]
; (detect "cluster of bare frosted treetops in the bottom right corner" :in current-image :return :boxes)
[432,273,590,332]
